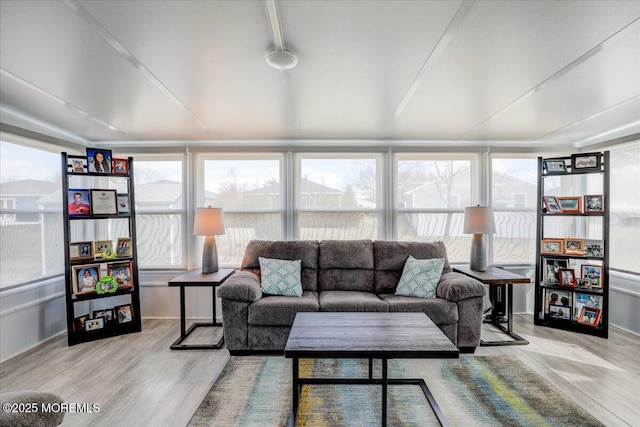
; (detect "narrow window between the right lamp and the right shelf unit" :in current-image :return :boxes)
[491,156,538,264]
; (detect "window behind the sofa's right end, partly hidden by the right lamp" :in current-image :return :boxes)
[394,154,475,262]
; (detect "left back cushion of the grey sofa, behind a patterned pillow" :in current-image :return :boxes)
[242,240,318,291]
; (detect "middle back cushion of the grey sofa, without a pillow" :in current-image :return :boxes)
[318,240,374,292]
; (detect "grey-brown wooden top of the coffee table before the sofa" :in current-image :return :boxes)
[284,312,460,359]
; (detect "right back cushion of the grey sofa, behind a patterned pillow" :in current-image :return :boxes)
[373,240,451,294]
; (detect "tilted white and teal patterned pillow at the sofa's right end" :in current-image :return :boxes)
[396,255,444,298]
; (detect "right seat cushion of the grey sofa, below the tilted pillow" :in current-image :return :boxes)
[380,294,458,325]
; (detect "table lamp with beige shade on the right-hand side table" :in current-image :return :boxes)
[462,205,496,271]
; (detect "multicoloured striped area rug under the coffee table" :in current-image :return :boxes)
[189,356,603,427]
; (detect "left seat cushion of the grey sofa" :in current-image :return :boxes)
[249,291,320,326]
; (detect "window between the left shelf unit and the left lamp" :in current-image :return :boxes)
[133,159,187,268]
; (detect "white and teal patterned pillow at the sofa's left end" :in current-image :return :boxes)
[258,257,302,297]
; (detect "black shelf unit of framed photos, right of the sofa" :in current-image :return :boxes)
[534,151,610,338]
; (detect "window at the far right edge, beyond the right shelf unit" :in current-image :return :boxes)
[605,141,640,274]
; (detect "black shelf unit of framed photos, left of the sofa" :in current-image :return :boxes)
[61,152,142,346]
